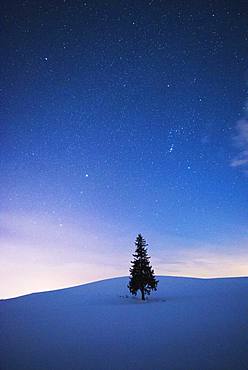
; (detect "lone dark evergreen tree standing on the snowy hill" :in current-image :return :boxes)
[128,234,158,301]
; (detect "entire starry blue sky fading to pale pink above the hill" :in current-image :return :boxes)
[0,0,248,298]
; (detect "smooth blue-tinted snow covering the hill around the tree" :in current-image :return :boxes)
[0,276,248,370]
